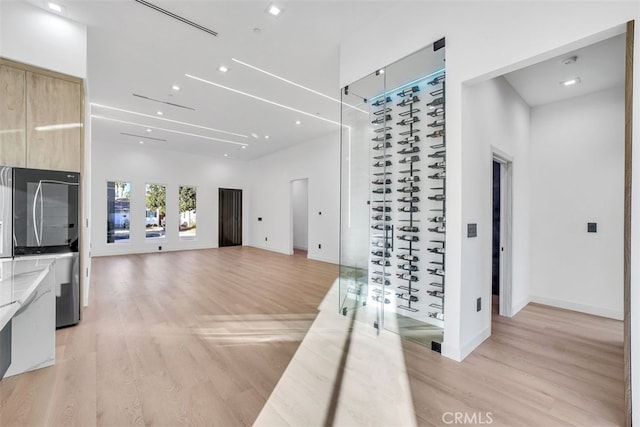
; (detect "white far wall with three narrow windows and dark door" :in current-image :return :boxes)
[91,142,249,256]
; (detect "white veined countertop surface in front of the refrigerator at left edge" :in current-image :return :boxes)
[0,257,55,329]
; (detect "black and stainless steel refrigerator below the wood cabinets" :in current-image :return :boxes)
[0,167,80,328]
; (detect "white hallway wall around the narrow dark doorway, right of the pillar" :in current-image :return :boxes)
[460,77,530,357]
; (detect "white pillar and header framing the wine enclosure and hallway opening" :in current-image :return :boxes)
[340,1,640,364]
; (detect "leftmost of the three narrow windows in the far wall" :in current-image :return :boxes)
[107,181,131,243]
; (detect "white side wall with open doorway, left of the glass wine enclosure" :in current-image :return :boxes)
[248,131,340,263]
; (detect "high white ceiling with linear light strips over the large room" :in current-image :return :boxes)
[29,0,385,160]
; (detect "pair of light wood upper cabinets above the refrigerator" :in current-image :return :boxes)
[0,59,84,172]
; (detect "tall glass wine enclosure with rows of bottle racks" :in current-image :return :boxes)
[340,40,446,351]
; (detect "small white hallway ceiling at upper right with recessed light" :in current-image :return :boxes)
[504,34,625,107]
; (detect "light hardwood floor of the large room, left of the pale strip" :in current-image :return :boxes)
[0,247,337,427]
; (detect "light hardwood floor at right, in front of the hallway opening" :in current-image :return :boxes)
[403,304,624,427]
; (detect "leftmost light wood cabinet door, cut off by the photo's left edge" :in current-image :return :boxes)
[0,64,27,167]
